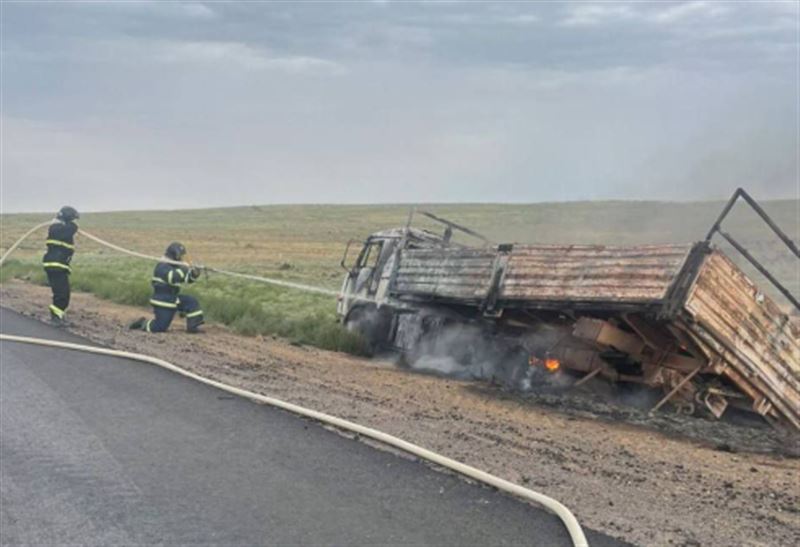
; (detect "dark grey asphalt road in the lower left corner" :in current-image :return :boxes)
[0,309,621,546]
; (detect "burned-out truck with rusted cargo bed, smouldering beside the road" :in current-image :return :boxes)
[337,189,800,430]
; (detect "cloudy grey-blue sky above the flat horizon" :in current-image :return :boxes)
[0,0,800,213]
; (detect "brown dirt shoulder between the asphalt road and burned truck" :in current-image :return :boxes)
[0,281,800,545]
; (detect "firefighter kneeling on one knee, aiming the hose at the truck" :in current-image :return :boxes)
[130,242,205,333]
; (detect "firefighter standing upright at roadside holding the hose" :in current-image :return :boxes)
[42,205,80,326]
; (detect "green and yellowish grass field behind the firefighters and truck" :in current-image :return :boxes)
[0,200,800,353]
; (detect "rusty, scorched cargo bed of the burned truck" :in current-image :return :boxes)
[389,242,800,429]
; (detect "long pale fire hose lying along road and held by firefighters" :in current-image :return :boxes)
[0,222,589,547]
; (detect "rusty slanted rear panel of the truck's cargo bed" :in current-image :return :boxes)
[684,250,800,428]
